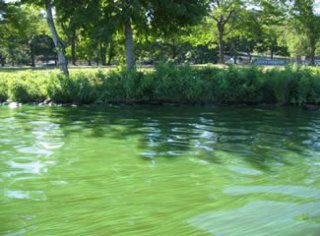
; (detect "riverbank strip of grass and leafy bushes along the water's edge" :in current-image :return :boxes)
[0,64,320,105]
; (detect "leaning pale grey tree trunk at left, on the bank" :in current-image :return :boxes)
[46,0,69,76]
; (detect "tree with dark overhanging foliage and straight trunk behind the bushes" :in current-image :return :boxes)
[103,0,207,70]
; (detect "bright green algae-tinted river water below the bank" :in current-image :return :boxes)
[0,106,320,236]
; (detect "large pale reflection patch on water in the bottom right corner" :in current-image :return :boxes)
[189,201,320,236]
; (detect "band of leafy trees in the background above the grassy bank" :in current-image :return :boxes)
[0,0,320,75]
